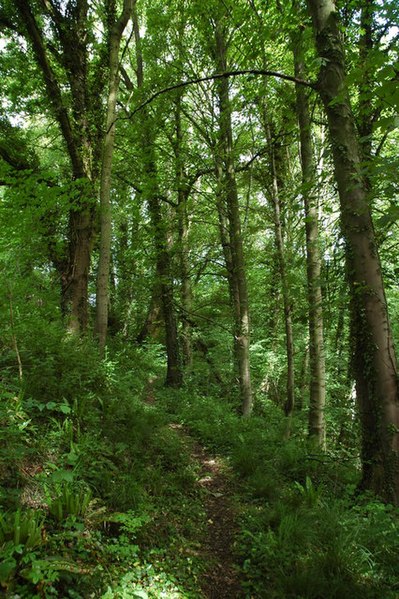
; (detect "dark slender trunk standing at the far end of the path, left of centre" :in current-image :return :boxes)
[133,6,183,387]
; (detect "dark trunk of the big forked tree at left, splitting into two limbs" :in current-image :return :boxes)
[15,0,99,333]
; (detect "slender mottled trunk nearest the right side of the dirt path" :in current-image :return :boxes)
[215,21,253,416]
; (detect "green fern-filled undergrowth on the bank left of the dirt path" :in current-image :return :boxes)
[0,336,205,599]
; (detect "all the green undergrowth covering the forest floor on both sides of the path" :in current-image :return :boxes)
[0,327,399,599]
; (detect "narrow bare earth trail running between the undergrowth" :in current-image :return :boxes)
[171,424,244,599]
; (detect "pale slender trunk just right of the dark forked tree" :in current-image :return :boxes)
[95,0,133,355]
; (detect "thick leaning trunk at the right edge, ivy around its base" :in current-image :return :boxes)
[308,0,399,504]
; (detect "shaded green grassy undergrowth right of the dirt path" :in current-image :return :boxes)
[159,392,399,599]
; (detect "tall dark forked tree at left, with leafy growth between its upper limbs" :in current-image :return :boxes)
[15,0,103,332]
